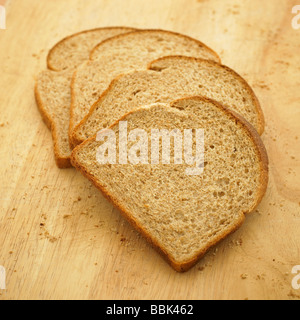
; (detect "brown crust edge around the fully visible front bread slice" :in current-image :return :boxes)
[71,97,269,272]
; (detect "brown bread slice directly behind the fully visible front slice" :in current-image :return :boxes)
[71,56,264,145]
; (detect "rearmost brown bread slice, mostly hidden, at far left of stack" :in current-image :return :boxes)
[35,27,134,168]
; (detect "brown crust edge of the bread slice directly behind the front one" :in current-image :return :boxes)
[70,55,265,149]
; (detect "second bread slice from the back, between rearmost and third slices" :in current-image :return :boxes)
[70,30,220,143]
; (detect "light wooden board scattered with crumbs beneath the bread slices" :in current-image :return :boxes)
[0,0,300,300]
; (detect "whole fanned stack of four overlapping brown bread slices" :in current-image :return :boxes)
[35,27,268,272]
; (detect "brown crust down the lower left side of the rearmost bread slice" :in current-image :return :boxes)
[34,79,72,169]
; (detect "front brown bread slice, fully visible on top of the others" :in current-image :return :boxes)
[71,97,268,272]
